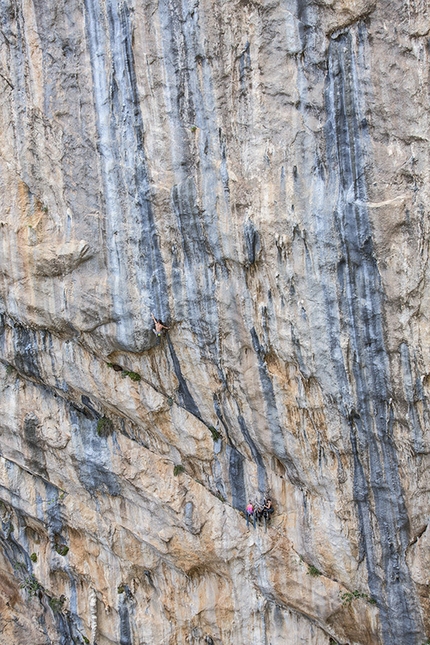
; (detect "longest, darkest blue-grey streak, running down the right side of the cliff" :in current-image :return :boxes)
[324,25,423,645]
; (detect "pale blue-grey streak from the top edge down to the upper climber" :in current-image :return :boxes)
[85,0,169,349]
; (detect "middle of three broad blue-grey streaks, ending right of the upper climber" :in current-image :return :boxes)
[158,0,231,352]
